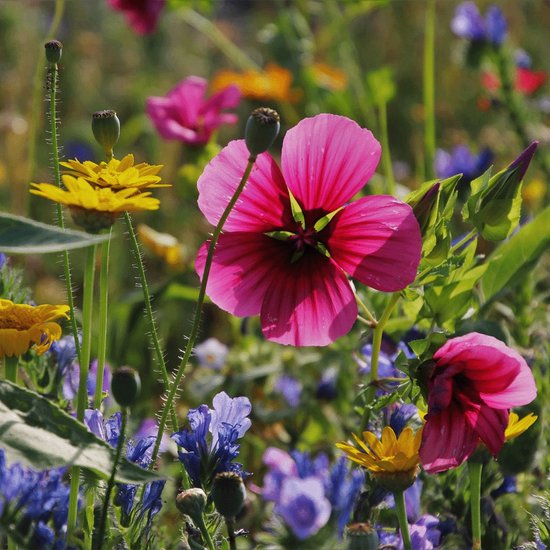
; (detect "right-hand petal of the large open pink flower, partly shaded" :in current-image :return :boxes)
[327,195,422,292]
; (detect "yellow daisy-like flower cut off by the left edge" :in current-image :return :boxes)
[0,299,69,358]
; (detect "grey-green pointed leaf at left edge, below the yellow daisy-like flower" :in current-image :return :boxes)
[0,212,109,254]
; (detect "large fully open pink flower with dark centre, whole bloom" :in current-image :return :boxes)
[196,114,421,346]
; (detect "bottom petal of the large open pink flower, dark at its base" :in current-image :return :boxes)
[261,250,357,346]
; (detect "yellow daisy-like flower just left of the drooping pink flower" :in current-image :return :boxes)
[336,426,422,491]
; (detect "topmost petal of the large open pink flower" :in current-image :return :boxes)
[281,114,381,213]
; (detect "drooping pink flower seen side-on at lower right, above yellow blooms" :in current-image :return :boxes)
[420,332,537,473]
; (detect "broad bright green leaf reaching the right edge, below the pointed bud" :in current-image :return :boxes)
[481,206,550,301]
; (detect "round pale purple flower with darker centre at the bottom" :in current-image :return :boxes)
[275,477,331,540]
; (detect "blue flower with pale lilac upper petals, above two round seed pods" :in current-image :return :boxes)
[171,392,252,488]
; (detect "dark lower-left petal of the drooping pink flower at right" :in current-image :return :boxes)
[419,406,479,474]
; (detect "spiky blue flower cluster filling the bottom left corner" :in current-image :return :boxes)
[0,449,74,549]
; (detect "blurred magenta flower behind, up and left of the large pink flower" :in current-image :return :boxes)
[147,76,241,145]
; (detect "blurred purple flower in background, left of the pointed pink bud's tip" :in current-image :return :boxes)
[434,145,493,183]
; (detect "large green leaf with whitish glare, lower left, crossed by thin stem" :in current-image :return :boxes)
[0,380,161,483]
